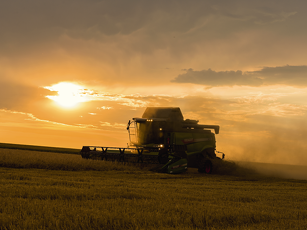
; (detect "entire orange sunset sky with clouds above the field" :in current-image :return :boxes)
[0,0,307,165]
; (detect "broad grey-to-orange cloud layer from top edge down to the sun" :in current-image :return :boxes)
[0,0,306,86]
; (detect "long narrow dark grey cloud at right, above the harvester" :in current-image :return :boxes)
[172,65,307,87]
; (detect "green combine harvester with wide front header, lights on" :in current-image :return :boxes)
[81,107,225,173]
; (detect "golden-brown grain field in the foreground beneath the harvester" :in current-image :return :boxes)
[0,149,307,229]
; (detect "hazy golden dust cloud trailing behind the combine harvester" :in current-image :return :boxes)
[217,122,307,180]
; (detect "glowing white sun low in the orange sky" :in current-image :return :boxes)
[44,82,87,108]
